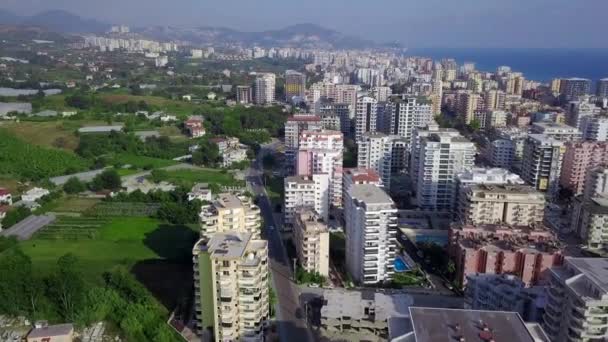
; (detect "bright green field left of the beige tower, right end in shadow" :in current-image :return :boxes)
[21,217,198,282]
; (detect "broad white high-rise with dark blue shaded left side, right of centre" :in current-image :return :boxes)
[416,133,477,210]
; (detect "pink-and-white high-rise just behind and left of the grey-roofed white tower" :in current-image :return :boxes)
[296,130,344,207]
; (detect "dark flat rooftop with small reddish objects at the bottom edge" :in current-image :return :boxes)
[410,307,535,342]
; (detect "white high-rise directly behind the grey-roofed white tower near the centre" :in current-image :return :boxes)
[357,133,406,189]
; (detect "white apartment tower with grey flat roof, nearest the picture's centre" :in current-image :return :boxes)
[344,184,397,284]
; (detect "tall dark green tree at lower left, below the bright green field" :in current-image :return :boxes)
[48,253,85,321]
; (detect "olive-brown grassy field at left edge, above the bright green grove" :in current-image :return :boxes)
[0,121,78,151]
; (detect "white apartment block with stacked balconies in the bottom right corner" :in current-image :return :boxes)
[542,258,608,342]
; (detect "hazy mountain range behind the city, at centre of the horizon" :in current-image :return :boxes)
[137,24,375,49]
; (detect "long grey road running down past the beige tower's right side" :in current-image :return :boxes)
[247,142,313,342]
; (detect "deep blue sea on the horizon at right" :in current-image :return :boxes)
[405,48,608,83]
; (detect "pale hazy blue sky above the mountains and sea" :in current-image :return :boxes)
[0,0,608,48]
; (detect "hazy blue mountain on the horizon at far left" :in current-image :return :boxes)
[0,9,110,33]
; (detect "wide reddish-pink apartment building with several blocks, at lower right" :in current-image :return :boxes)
[449,225,563,286]
